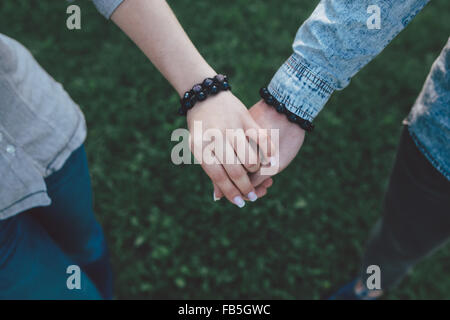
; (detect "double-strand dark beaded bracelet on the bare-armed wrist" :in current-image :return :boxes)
[178,74,231,116]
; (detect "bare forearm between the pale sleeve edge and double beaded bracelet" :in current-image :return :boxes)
[111,0,216,96]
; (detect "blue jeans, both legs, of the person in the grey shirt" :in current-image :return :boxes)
[0,146,112,299]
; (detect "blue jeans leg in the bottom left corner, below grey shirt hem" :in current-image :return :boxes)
[0,212,101,300]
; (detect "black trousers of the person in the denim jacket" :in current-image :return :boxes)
[360,127,450,290]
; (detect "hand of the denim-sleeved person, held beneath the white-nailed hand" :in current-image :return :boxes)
[215,100,305,198]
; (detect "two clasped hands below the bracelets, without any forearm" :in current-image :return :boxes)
[187,91,305,208]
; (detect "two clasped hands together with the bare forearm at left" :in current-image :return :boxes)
[111,0,305,207]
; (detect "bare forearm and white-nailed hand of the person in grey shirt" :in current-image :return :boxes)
[111,0,273,207]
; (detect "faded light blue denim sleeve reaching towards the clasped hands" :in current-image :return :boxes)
[268,0,428,121]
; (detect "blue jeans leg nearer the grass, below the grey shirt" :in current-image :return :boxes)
[29,146,113,299]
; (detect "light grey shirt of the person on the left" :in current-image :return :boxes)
[0,0,123,219]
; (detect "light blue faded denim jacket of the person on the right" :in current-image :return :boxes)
[268,0,450,179]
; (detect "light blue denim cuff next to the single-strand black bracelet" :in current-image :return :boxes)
[267,53,334,121]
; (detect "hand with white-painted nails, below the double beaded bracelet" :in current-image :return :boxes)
[187,91,276,207]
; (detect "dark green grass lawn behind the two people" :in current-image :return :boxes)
[0,0,450,299]
